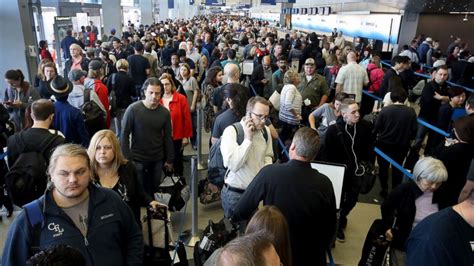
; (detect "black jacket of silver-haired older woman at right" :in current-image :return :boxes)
[380,182,449,251]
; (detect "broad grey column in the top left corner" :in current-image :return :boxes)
[0,0,39,87]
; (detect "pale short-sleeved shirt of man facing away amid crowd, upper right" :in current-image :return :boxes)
[336,62,369,103]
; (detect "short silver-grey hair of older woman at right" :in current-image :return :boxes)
[413,156,448,183]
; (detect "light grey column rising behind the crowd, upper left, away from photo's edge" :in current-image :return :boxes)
[102,0,123,38]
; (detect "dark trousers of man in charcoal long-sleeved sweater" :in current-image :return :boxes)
[133,161,163,199]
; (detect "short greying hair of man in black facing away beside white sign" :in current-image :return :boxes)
[293,127,320,161]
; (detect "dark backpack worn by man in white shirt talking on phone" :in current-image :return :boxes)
[207,122,268,188]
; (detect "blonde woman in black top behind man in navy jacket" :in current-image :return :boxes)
[87,129,159,225]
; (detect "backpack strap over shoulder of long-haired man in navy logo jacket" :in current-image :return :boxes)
[23,199,44,254]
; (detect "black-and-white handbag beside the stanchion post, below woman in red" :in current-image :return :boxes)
[154,174,191,211]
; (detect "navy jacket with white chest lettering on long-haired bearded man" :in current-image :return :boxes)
[1,185,144,266]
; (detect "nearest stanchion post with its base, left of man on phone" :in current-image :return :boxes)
[180,156,201,247]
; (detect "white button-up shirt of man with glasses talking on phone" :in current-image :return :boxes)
[221,121,273,189]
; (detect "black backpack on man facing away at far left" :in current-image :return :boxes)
[5,134,59,206]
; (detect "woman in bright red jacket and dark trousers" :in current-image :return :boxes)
[159,73,193,176]
